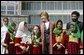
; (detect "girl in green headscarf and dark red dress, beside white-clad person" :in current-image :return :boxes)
[4,23,16,54]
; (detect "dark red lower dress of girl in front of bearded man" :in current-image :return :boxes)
[67,36,80,54]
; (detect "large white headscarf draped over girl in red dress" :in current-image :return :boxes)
[15,21,30,42]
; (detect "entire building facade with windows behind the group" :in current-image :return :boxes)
[1,1,83,29]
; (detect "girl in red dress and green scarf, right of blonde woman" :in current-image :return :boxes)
[52,20,67,54]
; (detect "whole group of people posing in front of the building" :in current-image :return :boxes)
[1,11,83,54]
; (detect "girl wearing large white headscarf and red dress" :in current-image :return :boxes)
[15,21,30,54]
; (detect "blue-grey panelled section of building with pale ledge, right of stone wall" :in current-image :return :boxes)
[21,1,83,27]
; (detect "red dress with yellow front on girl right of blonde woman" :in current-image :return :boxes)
[52,31,67,54]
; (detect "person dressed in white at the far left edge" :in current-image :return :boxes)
[1,17,9,54]
